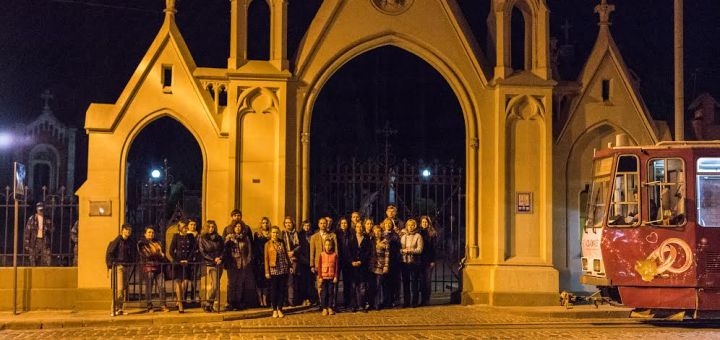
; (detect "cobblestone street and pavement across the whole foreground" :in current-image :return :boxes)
[0,306,720,339]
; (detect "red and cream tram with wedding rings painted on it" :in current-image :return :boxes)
[580,142,720,317]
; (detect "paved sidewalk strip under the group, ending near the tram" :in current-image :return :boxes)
[0,305,630,329]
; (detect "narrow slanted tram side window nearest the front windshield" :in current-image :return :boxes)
[608,155,640,226]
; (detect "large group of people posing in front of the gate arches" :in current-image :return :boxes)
[106,205,437,318]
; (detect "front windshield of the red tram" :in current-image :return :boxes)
[585,157,613,228]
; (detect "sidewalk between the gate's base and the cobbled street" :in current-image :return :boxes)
[0,305,631,330]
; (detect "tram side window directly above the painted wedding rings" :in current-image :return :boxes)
[647,158,686,226]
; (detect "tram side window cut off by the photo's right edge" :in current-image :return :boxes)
[696,157,720,227]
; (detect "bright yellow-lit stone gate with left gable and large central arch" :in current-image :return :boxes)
[7,0,559,308]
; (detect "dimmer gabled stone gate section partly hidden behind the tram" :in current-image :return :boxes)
[552,9,670,292]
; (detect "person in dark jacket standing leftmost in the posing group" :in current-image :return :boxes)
[105,223,136,315]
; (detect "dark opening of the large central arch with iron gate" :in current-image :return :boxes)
[310,47,465,303]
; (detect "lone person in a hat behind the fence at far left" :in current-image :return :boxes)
[23,202,53,267]
